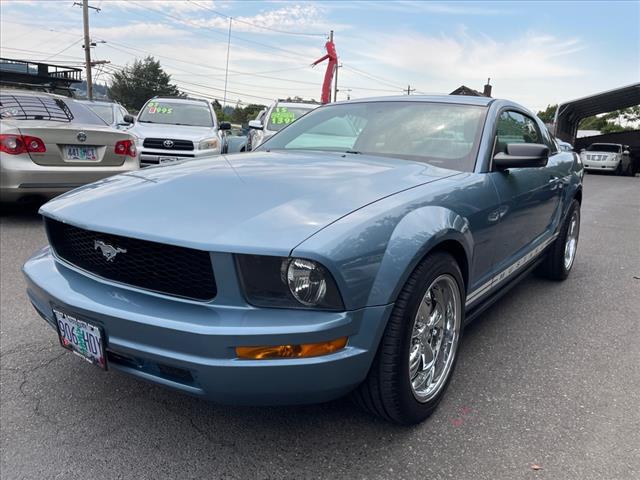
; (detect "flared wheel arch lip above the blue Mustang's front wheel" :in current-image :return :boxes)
[367,206,474,305]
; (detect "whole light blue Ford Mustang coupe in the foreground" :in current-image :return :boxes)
[24,96,583,424]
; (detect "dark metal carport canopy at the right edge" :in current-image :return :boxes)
[554,83,640,143]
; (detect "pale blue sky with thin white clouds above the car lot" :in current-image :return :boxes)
[0,0,640,111]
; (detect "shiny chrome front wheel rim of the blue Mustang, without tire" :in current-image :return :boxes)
[409,274,462,403]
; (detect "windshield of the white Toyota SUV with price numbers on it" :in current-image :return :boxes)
[138,100,213,127]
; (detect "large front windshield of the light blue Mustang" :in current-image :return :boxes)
[259,101,486,171]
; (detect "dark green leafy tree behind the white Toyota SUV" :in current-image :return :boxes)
[109,56,185,111]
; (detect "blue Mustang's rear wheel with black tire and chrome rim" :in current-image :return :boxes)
[536,199,580,281]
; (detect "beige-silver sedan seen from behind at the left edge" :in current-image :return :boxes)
[0,89,139,202]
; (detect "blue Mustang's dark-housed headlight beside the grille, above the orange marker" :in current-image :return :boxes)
[236,255,344,310]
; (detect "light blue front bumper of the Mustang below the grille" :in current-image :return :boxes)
[23,247,392,405]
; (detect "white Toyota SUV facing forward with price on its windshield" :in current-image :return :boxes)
[132,97,231,167]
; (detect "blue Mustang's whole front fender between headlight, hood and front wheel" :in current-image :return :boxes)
[290,199,474,310]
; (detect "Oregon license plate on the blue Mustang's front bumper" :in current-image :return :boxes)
[53,309,107,370]
